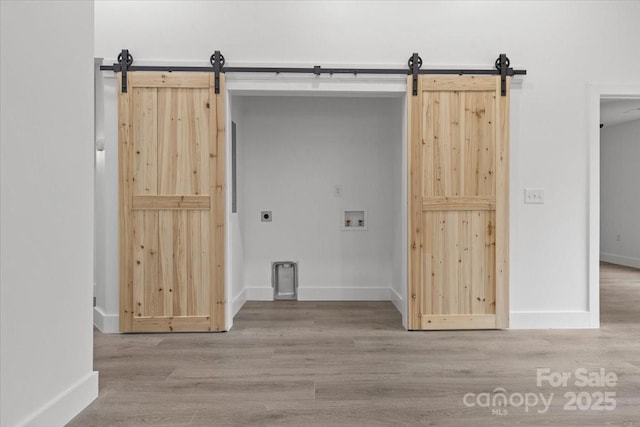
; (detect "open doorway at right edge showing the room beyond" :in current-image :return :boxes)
[599,96,640,323]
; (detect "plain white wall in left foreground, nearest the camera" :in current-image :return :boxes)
[0,1,98,427]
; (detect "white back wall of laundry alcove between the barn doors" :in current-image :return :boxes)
[232,96,403,300]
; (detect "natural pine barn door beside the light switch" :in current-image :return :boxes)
[407,76,509,329]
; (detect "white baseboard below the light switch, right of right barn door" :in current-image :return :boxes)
[509,311,597,329]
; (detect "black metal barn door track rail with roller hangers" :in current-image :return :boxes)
[100,49,527,96]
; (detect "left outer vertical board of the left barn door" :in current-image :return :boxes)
[118,74,133,332]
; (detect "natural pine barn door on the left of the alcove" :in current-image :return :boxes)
[118,71,225,332]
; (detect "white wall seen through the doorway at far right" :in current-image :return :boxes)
[600,120,640,268]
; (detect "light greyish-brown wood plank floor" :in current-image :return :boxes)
[69,264,640,426]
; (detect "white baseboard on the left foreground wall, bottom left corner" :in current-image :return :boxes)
[16,371,98,427]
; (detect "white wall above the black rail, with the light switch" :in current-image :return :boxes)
[96,1,640,327]
